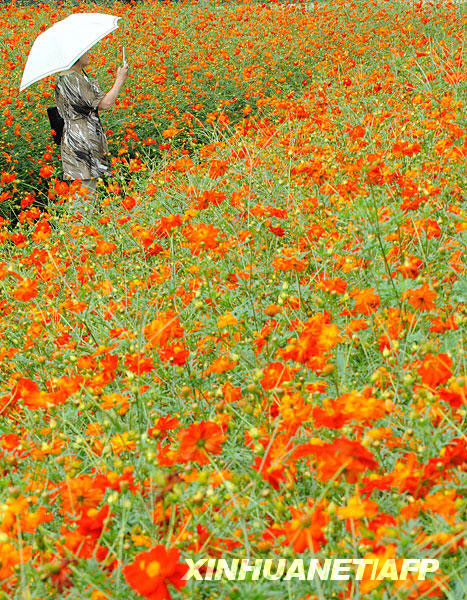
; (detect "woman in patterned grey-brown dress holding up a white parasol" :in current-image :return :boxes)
[55,52,128,216]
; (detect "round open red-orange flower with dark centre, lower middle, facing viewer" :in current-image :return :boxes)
[178,421,225,465]
